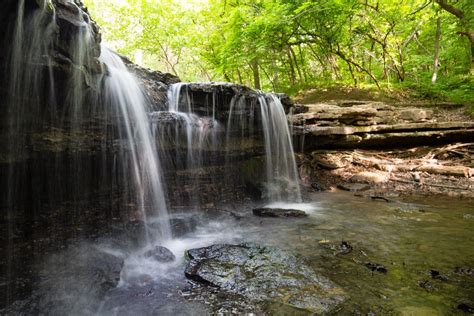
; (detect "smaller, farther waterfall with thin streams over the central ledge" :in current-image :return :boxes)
[165,83,301,202]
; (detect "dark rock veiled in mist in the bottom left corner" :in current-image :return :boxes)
[6,245,124,315]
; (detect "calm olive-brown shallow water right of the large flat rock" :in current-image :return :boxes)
[256,194,474,315]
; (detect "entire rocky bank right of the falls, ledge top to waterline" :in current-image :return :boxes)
[289,100,474,198]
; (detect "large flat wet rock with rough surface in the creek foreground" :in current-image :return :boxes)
[185,243,345,313]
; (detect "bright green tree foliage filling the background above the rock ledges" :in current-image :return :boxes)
[85,0,474,103]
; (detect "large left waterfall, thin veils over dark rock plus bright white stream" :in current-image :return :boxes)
[0,0,171,240]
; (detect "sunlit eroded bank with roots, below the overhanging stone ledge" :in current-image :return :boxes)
[297,144,474,199]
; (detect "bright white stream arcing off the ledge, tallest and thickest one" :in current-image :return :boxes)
[100,48,171,241]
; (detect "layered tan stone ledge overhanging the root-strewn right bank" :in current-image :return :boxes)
[290,101,474,151]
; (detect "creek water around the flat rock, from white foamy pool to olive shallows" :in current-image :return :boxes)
[93,192,474,315]
